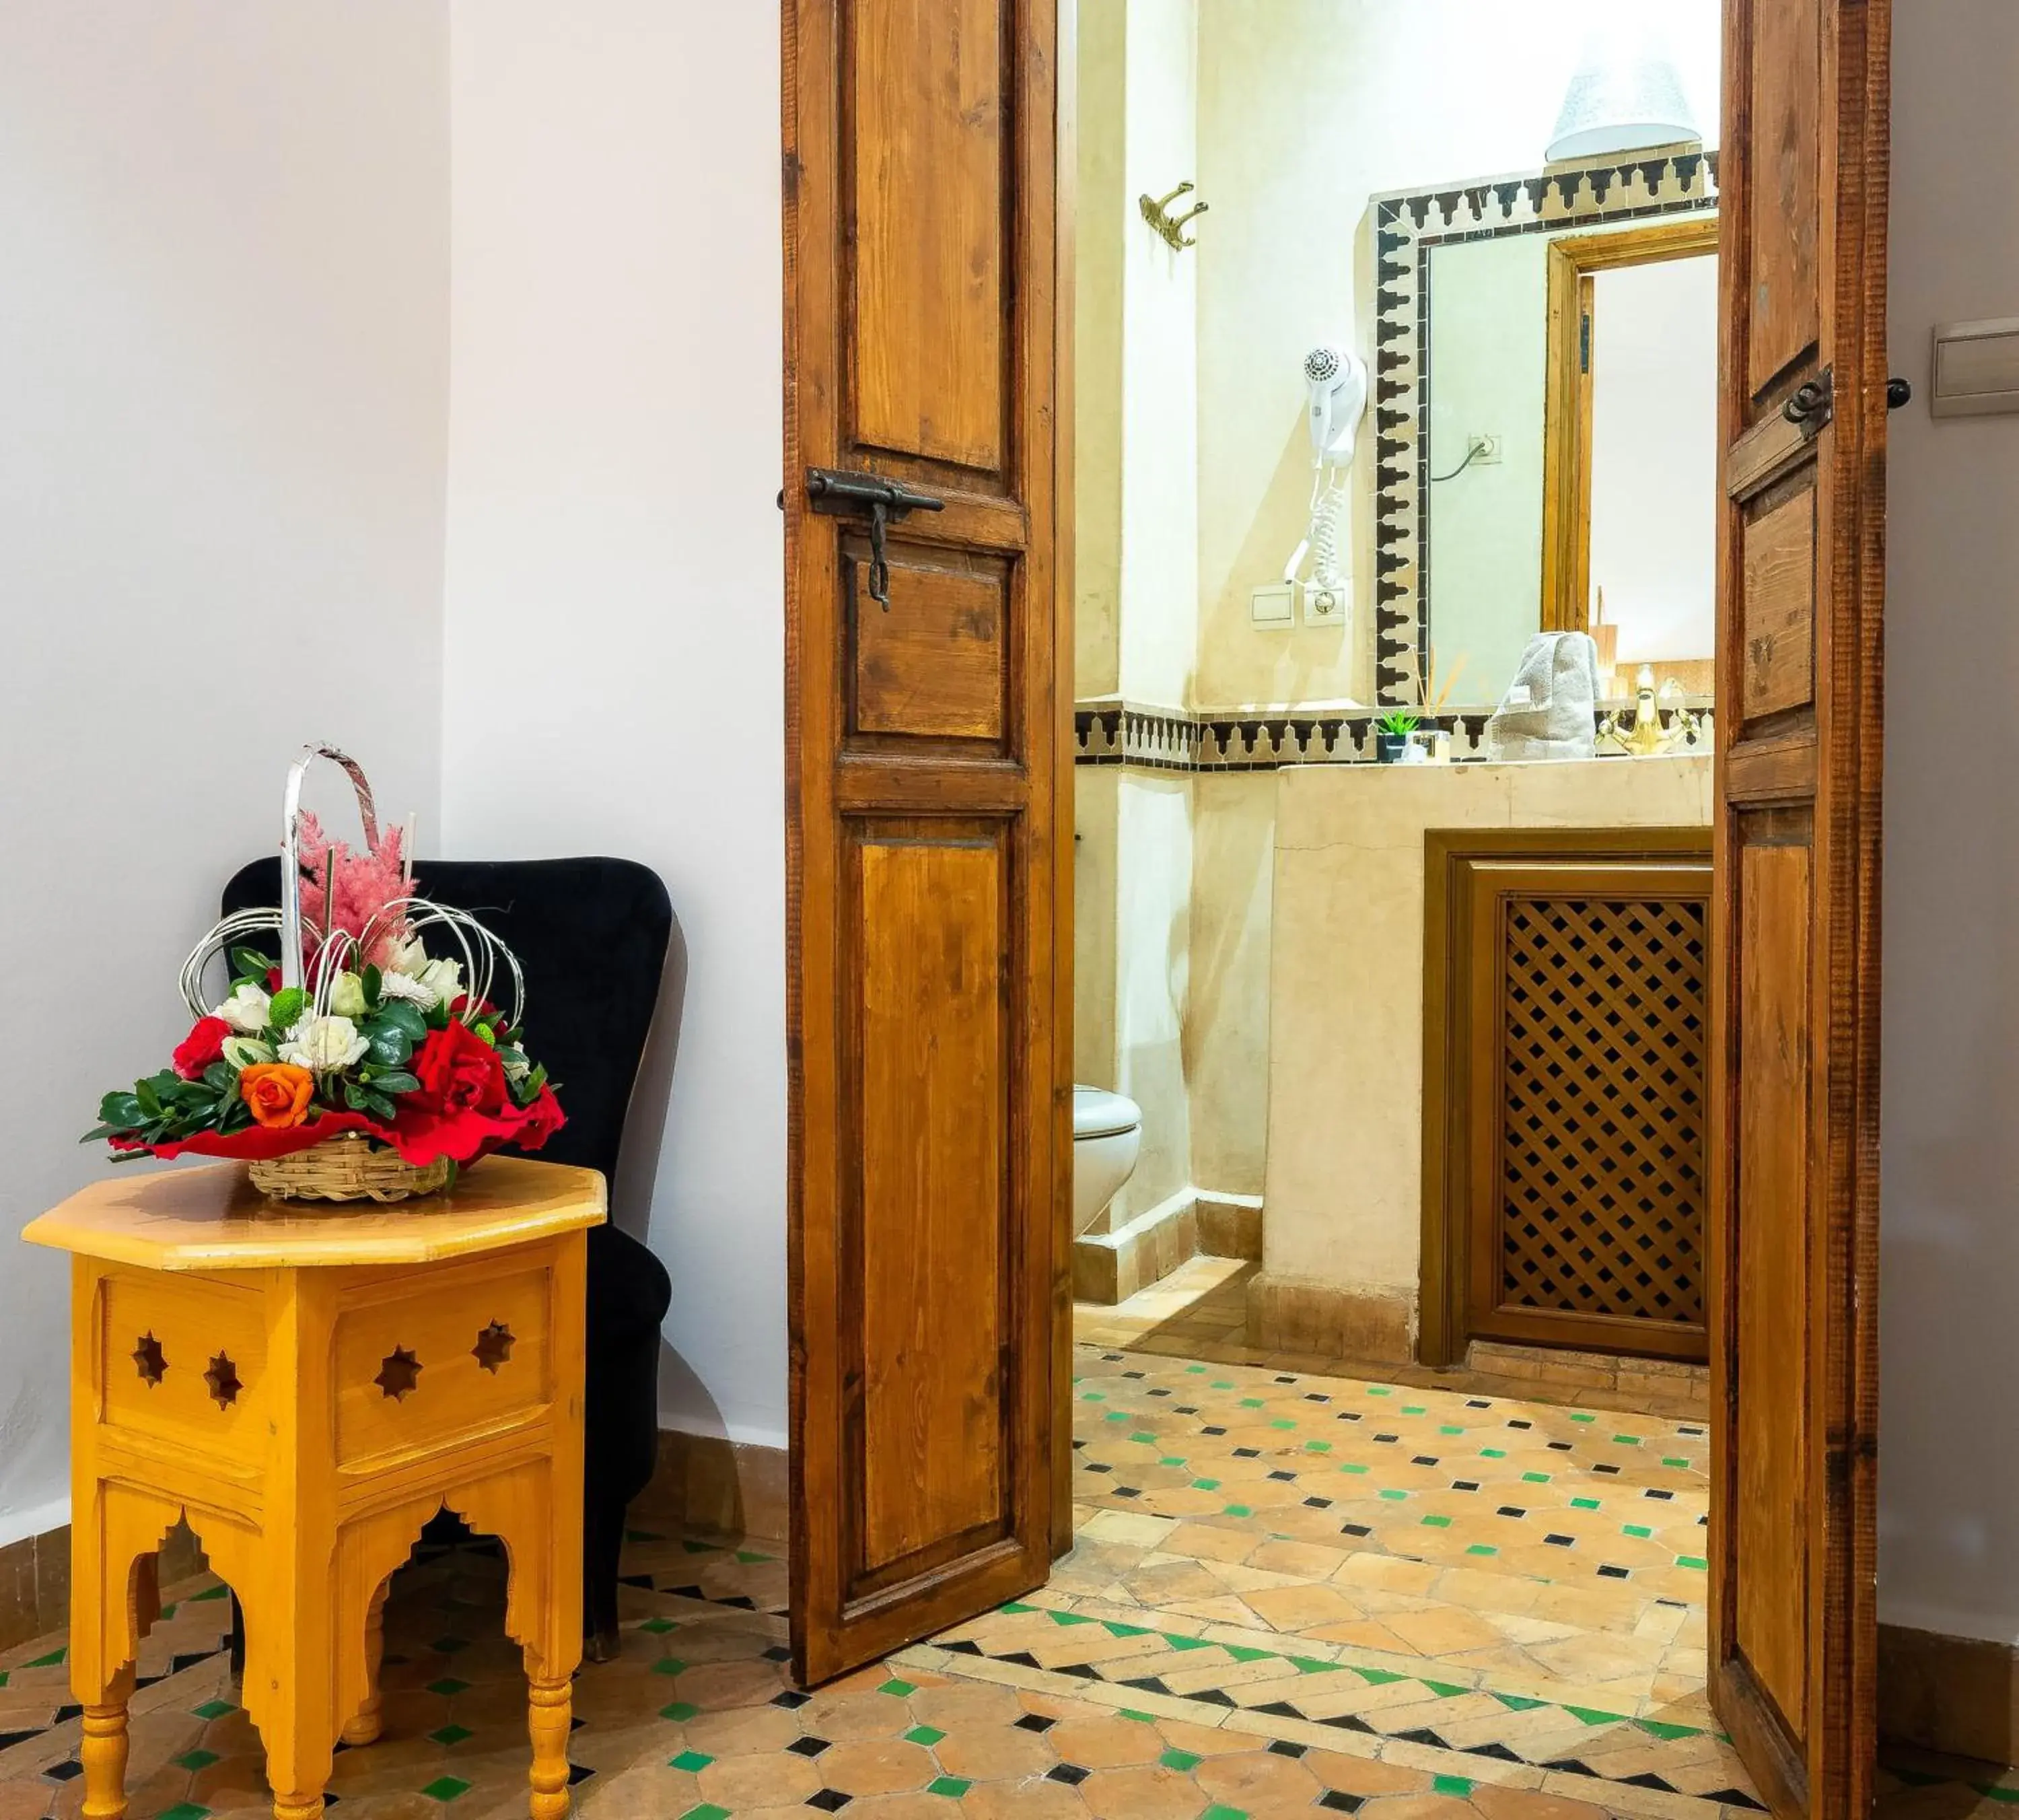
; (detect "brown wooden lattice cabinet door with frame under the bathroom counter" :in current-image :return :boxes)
[1423,830,1710,1362]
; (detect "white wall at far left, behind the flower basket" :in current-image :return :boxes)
[0,0,448,1543]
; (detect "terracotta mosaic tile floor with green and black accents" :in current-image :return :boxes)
[0,1345,2019,1820]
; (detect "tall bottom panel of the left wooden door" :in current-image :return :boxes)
[846,824,1016,1596]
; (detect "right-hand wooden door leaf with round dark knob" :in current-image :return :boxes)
[1710,0,1888,1816]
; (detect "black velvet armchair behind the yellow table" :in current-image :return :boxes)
[224,858,672,1660]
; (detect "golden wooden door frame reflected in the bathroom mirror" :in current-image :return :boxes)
[1543,214,1718,632]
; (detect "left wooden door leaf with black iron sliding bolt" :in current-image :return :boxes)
[783,0,1072,1683]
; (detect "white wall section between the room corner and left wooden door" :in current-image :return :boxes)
[442,0,785,1444]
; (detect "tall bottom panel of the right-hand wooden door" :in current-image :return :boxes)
[1734,846,1811,1741]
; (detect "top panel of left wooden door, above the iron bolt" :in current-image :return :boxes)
[846,0,1010,475]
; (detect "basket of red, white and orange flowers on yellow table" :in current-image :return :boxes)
[85,745,563,1202]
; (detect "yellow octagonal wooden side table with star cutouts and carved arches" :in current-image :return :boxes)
[22,1158,604,1820]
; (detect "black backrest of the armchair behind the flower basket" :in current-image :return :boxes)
[224,854,672,1180]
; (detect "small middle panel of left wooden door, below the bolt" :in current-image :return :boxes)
[842,537,1012,751]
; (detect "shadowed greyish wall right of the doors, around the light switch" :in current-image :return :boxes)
[1880,0,2019,1642]
